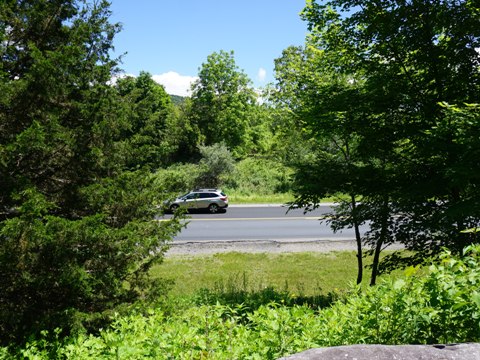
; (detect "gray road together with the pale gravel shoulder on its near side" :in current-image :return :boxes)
[159,205,374,254]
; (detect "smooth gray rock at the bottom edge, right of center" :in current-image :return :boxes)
[280,344,480,360]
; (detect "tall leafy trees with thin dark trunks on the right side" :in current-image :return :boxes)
[276,0,480,284]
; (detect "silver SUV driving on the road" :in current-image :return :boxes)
[169,189,228,214]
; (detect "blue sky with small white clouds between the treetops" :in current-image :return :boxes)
[110,0,307,95]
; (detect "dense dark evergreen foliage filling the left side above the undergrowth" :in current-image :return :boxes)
[0,0,180,344]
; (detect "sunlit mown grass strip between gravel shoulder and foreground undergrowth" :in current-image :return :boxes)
[152,252,357,297]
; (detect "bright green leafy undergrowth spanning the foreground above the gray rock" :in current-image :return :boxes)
[0,247,480,359]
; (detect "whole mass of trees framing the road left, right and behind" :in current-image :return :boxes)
[0,0,480,343]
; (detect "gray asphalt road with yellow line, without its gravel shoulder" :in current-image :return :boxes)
[165,205,368,242]
